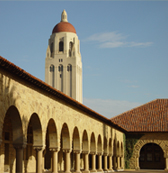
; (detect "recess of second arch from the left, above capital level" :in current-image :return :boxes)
[27,113,43,147]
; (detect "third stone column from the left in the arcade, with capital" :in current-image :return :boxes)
[50,148,58,173]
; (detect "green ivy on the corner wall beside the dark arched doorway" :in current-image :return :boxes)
[123,134,143,169]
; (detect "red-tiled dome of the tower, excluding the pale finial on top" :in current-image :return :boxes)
[52,22,76,34]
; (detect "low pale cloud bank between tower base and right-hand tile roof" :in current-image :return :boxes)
[84,98,142,118]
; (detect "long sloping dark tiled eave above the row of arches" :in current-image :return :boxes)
[0,56,126,132]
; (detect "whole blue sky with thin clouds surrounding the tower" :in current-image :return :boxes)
[0,1,168,118]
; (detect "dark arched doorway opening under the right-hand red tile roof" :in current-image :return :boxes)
[139,143,165,169]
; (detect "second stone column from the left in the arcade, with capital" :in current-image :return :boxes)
[34,146,43,173]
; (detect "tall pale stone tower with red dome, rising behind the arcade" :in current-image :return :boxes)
[45,10,83,103]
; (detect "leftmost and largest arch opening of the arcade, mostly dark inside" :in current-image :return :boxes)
[1,105,25,172]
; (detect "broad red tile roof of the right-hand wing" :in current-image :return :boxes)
[111,99,168,132]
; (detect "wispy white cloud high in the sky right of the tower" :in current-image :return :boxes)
[85,31,153,48]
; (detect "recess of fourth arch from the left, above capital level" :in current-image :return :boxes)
[61,123,70,150]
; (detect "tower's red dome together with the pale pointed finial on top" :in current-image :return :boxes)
[52,10,76,34]
